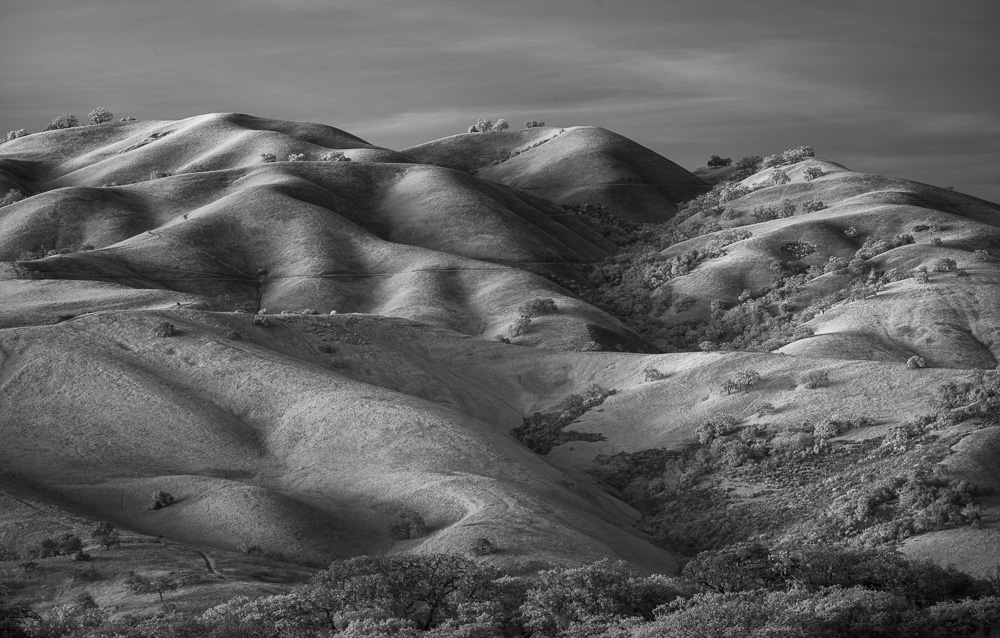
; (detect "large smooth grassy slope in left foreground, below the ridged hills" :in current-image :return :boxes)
[0,311,673,571]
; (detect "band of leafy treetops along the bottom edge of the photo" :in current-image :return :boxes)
[0,543,1000,638]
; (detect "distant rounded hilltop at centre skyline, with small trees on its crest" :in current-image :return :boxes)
[403,126,708,222]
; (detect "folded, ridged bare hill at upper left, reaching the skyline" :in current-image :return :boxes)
[0,120,631,348]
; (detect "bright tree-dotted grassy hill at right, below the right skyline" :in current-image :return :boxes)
[660,159,1000,368]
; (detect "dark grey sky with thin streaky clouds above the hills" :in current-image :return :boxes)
[0,0,1000,202]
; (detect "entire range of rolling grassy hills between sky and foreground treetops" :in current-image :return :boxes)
[0,119,1000,635]
